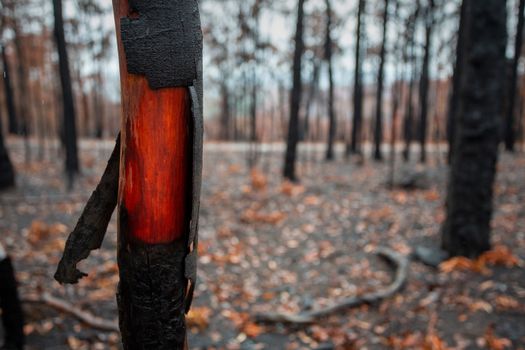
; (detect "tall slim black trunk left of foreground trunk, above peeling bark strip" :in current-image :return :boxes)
[53,0,79,186]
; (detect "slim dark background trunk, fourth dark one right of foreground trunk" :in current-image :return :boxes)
[374,0,389,160]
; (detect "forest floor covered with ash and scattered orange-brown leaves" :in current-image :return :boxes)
[0,139,525,350]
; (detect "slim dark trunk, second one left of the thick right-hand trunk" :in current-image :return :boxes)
[418,0,434,163]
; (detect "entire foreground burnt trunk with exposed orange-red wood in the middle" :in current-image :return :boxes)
[113,0,203,350]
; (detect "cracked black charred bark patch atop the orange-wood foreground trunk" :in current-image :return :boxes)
[121,0,201,89]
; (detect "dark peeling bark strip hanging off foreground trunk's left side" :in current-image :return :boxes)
[55,134,120,284]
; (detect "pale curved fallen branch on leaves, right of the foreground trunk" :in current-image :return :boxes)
[255,248,409,324]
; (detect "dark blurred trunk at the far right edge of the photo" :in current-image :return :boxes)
[504,0,525,152]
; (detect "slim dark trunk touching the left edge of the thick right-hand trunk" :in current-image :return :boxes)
[447,1,466,164]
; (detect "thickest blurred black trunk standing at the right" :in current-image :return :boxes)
[442,0,507,257]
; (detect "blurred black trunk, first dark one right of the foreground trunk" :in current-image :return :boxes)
[283,0,305,181]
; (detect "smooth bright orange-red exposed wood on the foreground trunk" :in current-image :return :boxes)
[113,0,192,244]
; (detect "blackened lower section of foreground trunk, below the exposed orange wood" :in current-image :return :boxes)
[117,231,187,350]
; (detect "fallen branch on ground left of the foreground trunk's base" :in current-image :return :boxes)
[22,293,119,332]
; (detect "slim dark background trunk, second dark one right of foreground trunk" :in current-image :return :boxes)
[324,0,337,160]
